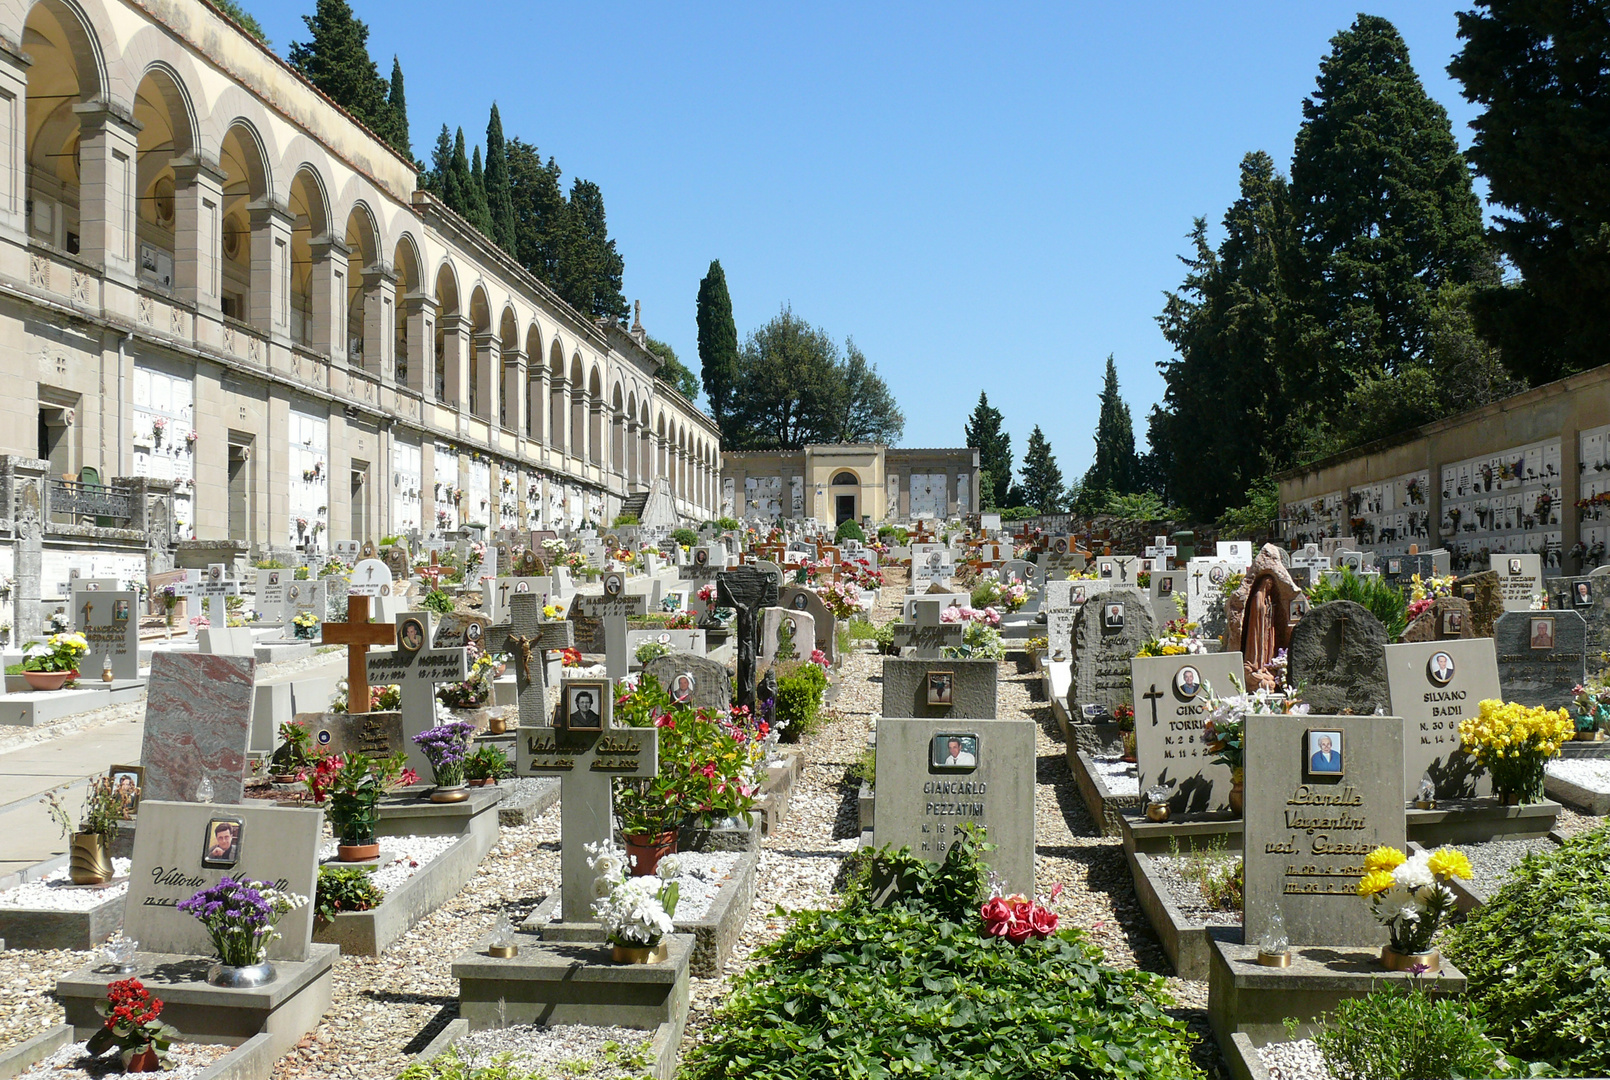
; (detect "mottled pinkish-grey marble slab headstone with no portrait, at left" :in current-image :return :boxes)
[140,652,258,803]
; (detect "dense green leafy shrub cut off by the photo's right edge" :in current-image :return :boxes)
[1443,826,1610,1077]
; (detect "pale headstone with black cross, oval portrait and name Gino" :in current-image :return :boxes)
[1130,652,1241,814]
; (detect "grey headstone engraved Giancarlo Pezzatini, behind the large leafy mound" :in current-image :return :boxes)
[873,718,1035,897]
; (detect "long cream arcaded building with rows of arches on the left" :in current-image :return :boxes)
[0,0,721,555]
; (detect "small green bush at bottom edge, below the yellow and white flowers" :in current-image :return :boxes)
[1315,982,1515,1080]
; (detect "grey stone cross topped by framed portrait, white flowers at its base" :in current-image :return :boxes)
[515,719,660,922]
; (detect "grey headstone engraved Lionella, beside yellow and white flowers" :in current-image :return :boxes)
[1236,713,1406,946]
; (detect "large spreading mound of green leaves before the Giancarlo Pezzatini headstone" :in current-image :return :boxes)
[679,832,1203,1080]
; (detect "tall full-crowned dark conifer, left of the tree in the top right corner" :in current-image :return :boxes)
[1291,14,1494,389]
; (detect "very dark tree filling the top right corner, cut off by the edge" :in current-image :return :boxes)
[1447,0,1610,383]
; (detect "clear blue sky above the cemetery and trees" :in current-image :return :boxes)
[254,0,1475,478]
